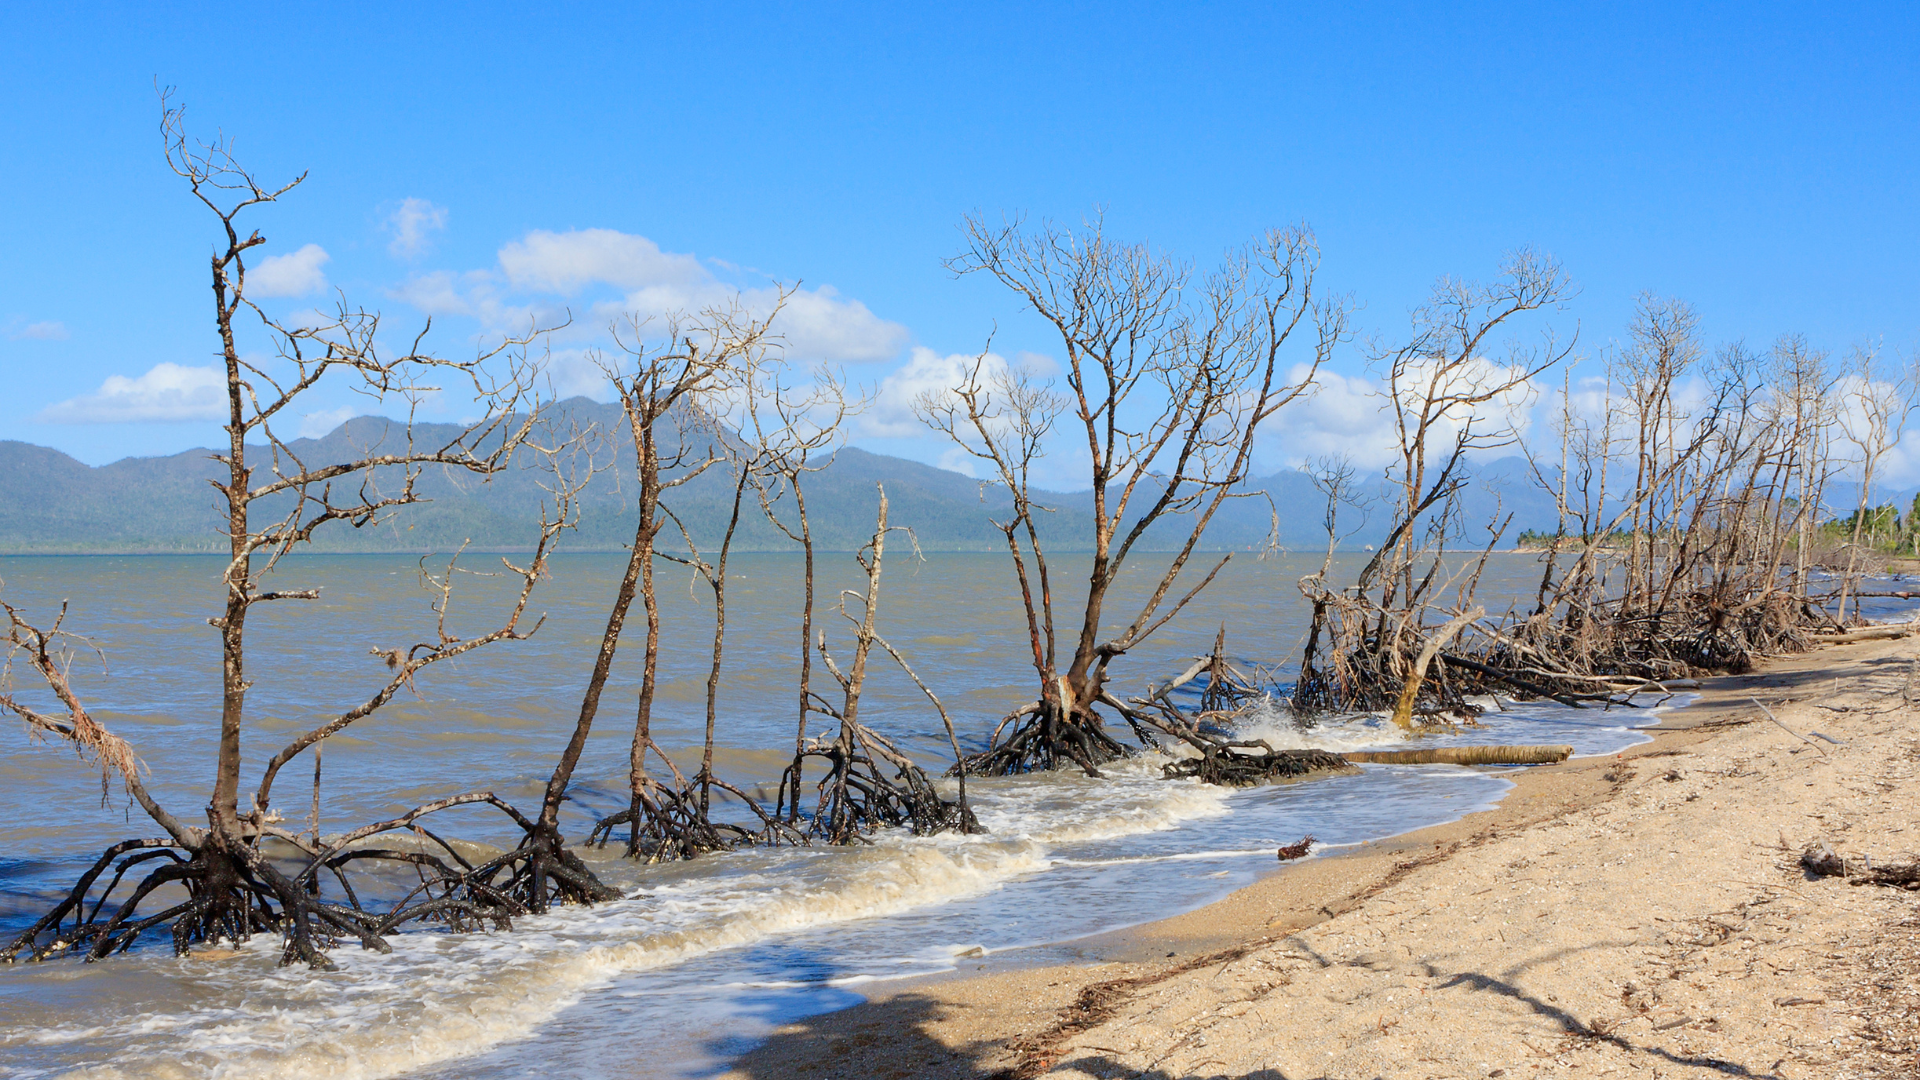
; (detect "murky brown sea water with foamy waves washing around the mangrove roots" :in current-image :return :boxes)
[0,555,1797,1080]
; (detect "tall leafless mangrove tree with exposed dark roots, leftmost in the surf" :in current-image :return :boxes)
[0,94,578,969]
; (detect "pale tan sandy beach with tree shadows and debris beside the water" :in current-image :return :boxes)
[726,638,1920,1080]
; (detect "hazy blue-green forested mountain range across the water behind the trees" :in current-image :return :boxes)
[0,398,1553,553]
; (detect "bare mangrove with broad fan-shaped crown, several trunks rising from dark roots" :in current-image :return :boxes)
[916,219,1346,774]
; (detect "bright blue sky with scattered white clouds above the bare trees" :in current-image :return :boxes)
[0,4,1920,478]
